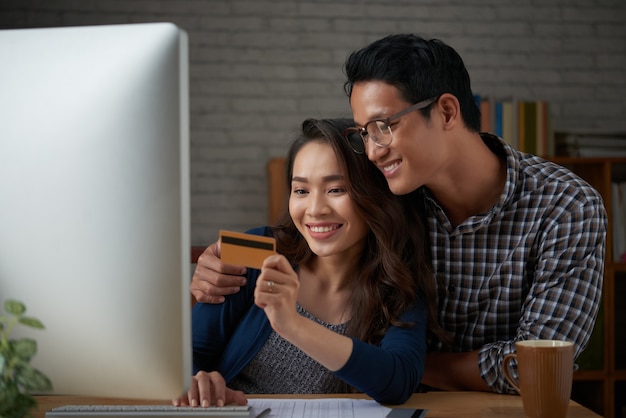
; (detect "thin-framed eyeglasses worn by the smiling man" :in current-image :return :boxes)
[343,96,439,154]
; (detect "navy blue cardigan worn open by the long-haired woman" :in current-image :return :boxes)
[192,227,426,404]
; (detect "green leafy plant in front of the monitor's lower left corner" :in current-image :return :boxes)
[0,299,52,418]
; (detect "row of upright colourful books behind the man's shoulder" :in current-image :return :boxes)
[475,95,555,157]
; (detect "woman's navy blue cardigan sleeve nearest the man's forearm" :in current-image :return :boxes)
[335,302,426,404]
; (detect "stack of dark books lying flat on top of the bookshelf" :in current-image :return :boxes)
[555,132,626,157]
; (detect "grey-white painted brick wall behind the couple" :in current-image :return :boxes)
[0,0,626,245]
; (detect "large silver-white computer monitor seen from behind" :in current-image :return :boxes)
[0,23,192,399]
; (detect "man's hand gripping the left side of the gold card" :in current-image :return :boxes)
[189,241,246,303]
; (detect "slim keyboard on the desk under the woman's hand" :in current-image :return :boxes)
[46,405,252,418]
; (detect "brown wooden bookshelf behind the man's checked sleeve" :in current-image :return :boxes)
[548,157,626,418]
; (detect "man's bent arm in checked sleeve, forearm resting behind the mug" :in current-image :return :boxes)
[422,198,606,393]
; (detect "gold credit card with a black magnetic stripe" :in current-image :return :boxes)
[220,230,276,269]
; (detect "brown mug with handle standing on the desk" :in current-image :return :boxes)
[502,340,574,418]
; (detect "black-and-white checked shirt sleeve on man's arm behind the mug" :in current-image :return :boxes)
[478,198,607,393]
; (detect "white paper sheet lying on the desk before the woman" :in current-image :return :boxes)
[248,398,391,418]
